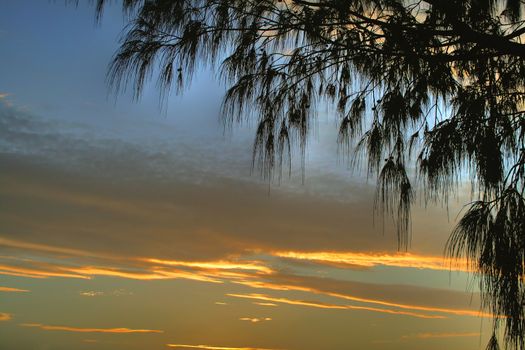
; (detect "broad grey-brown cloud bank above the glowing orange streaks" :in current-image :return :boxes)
[0,99,458,258]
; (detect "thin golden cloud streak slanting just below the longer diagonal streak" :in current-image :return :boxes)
[226,293,446,319]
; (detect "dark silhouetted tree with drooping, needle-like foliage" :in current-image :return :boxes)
[97,0,525,350]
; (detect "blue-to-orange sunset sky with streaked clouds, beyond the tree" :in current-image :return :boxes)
[0,0,492,350]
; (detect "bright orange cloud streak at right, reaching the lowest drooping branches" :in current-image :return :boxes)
[272,251,468,271]
